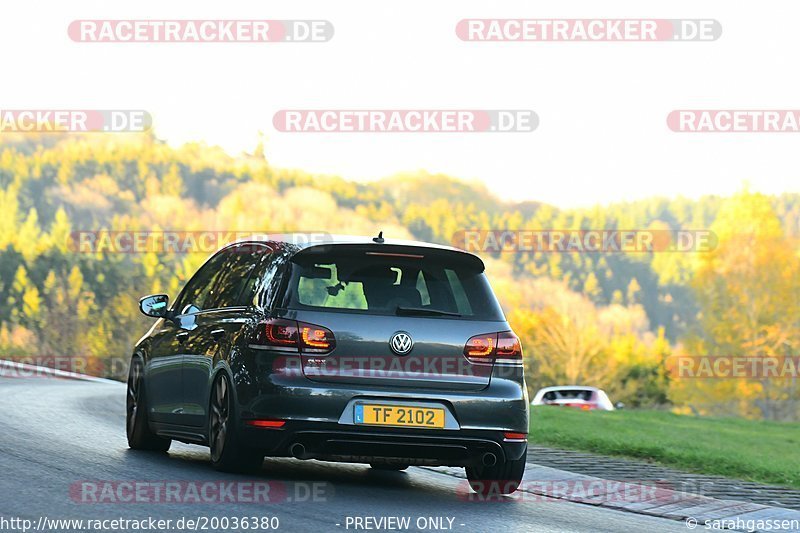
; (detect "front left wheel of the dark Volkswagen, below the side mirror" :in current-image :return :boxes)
[125,356,172,452]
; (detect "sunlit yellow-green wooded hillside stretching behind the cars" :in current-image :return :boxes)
[0,134,800,420]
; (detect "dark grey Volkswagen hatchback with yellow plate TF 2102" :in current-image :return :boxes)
[127,236,528,494]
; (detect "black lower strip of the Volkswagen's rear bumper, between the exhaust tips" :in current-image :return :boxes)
[242,421,527,466]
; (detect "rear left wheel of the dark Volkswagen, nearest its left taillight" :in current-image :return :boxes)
[208,373,264,472]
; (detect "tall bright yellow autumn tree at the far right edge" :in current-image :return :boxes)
[673,191,800,420]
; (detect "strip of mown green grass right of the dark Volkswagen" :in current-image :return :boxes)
[530,407,800,489]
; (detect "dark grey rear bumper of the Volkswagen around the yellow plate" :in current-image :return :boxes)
[237,354,529,466]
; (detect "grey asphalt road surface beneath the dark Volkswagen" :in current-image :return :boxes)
[0,378,687,533]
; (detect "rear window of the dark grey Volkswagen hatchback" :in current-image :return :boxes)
[287,247,504,320]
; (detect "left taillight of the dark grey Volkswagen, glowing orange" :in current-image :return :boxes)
[253,318,336,354]
